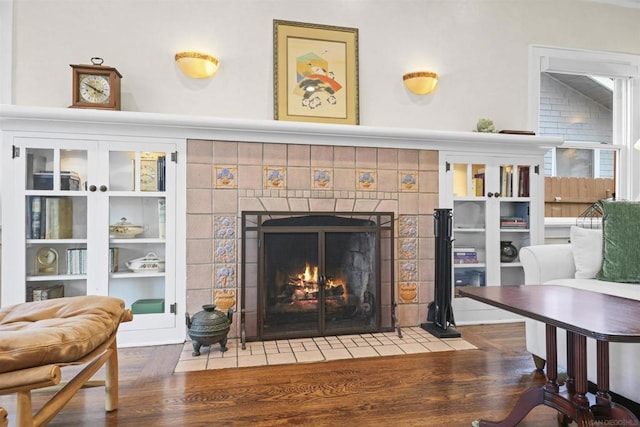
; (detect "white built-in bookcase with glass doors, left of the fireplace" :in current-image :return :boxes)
[2,133,184,344]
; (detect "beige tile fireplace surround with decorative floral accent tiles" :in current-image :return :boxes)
[186,139,438,336]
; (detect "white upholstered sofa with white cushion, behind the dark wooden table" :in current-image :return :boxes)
[520,227,640,403]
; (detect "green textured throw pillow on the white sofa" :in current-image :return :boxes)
[596,200,640,283]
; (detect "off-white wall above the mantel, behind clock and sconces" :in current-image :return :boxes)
[8,0,640,130]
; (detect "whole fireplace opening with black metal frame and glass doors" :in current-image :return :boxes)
[241,212,394,340]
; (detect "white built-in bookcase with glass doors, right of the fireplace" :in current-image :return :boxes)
[440,153,544,323]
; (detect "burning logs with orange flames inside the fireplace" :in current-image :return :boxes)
[283,262,347,303]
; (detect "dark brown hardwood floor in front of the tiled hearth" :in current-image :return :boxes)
[0,323,636,426]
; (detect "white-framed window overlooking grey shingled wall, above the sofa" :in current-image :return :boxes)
[529,46,640,219]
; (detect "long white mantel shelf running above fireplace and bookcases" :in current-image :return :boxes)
[0,104,563,155]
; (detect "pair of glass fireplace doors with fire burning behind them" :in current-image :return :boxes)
[260,228,380,339]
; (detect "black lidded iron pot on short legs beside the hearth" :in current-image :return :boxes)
[185,304,233,356]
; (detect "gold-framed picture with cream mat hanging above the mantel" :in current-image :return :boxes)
[273,20,360,125]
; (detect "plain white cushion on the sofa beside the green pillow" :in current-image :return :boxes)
[569,225,602,279]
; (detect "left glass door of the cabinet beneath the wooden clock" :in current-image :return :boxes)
[22,138,95,301]
